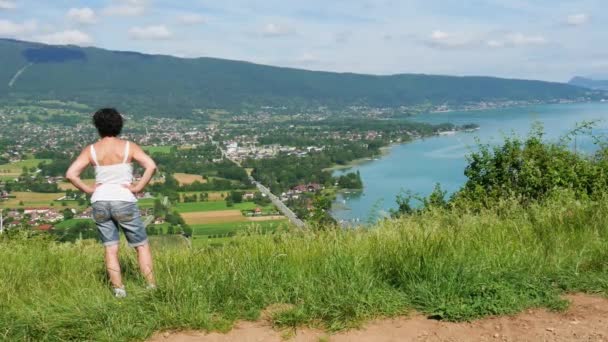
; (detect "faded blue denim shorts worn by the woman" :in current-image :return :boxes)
[92,201,148,247]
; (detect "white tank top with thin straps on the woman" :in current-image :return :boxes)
[91,141,137,203]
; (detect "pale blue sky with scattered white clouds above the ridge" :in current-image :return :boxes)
[0,0,608,82]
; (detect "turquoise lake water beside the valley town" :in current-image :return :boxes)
[333,103,608,223]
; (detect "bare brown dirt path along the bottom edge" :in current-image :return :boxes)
[150,295,608,342]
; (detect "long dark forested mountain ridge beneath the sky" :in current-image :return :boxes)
[0,39,600,115]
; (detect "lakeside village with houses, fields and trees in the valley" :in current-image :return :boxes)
[0,100,494,235]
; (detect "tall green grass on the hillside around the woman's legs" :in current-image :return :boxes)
[0,193,608,341]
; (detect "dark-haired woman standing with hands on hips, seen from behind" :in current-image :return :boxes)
[66,108,156,298]
